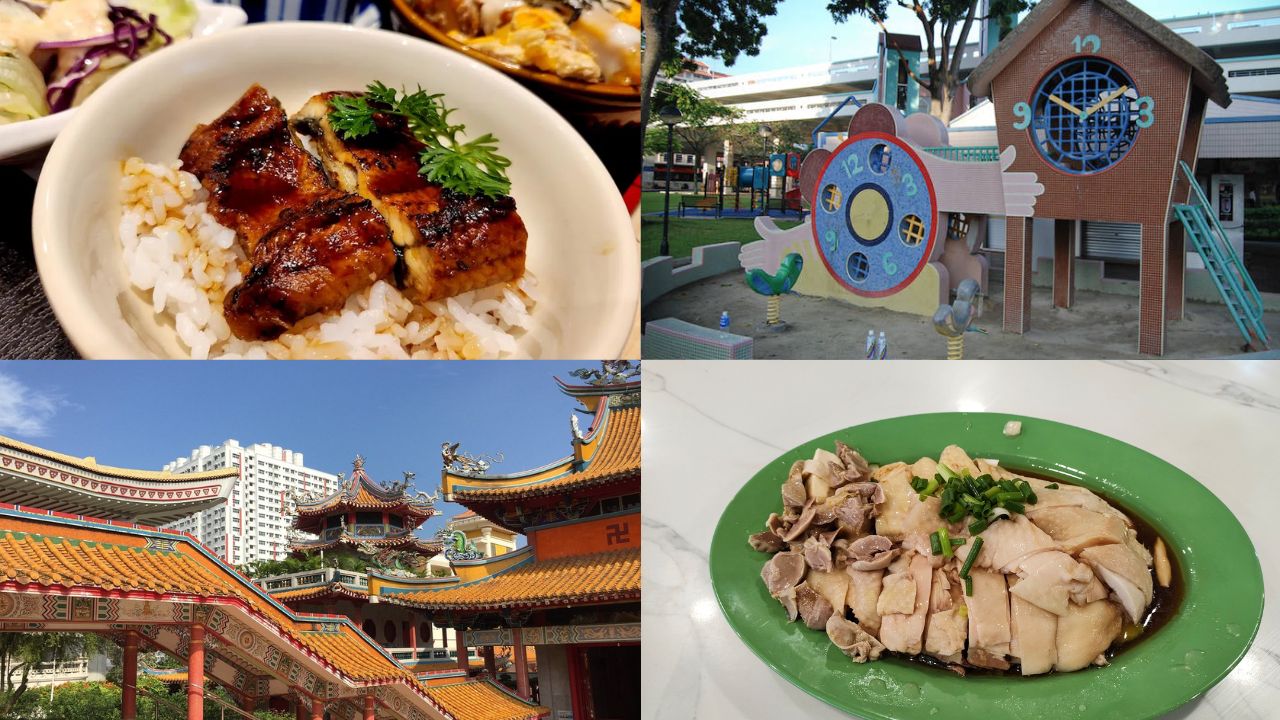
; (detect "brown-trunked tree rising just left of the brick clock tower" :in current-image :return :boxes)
[827,0,1029,122]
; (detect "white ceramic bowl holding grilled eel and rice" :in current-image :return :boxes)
[32,23,640,359]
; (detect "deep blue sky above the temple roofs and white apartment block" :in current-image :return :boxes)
[0,361,599,540]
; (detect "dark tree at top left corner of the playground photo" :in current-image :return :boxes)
[640,0,778,127]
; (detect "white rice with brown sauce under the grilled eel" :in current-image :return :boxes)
[119,158,545,359]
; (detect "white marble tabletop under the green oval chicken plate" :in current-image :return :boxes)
[641,360,1280,720]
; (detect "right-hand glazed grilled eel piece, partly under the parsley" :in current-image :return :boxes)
[293,92,529,302]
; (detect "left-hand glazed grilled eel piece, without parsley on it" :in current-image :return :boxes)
[180,85,396,340]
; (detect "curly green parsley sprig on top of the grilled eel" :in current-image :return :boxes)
[329,82,511,199]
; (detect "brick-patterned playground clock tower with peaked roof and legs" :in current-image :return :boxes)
[968,0,1230,355]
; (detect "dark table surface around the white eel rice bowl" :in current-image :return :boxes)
[0,106,640,360]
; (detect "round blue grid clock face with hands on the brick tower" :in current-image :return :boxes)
[1029,56,1155,176]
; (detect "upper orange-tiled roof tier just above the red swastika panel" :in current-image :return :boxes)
[453,407,640,503]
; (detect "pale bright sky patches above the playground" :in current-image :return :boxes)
[701,0,1277,74]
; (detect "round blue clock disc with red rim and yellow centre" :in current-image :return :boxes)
[812,132,938,297]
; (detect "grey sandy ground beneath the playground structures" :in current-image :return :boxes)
[644,272,1280,360]
